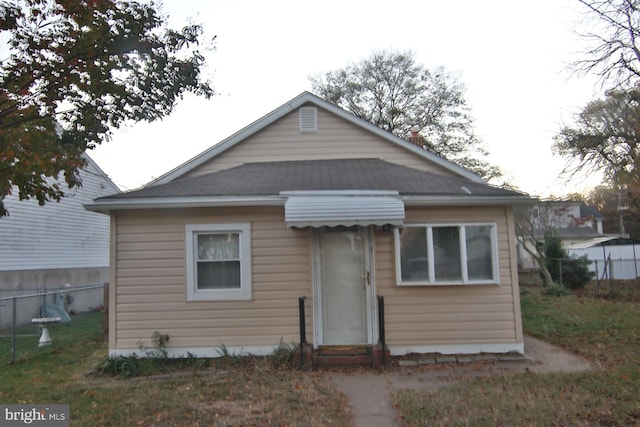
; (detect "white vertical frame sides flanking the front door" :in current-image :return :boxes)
[311,226,378,349]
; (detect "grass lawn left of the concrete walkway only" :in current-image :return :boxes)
[0,313,350,426]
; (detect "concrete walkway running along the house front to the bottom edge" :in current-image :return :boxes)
[331,336,593,427]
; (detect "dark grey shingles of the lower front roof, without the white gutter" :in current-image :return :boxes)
[102,159,522,199]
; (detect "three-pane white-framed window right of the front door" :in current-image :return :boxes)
[395,224,498,285]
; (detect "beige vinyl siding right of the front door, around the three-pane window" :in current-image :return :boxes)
[376,207,522,346]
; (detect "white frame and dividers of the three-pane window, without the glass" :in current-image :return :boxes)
[393,222,500,286]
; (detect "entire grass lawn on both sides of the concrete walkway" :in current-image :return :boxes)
[5,283,640,426]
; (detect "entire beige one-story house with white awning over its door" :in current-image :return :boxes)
[87,92,528,366]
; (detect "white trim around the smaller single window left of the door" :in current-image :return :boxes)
[185,223,251,301]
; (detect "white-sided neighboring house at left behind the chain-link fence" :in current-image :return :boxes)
[0,155,120,290]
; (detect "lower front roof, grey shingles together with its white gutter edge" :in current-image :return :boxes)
[88,159,529,211]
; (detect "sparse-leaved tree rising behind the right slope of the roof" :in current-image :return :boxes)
[310,51,502,180]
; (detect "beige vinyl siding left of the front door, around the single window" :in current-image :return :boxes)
[110,207,311,349]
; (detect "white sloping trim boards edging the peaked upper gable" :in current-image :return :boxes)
[147,92,484,187]
